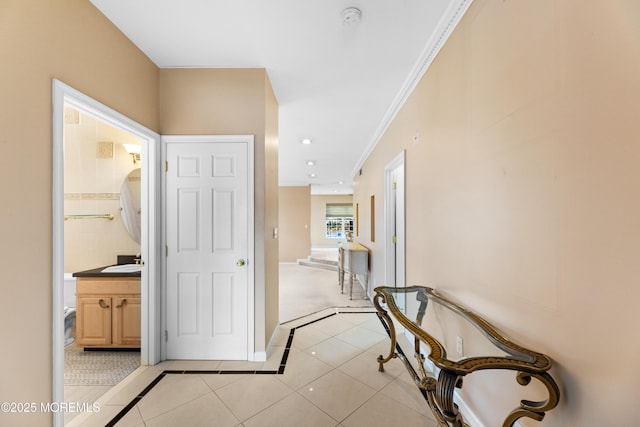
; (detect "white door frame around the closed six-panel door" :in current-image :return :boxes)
[160,135,255,361]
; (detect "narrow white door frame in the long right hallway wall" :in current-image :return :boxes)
[384,150,406,286]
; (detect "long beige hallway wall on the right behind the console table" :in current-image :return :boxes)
[355,0,640,427]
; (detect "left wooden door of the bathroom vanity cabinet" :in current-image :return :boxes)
[76,297,112,346]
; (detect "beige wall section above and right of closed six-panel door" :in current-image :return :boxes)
[160,69,278,351]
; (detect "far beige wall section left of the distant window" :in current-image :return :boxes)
[280,185,311,262]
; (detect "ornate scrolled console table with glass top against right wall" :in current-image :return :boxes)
[373,286,560,427]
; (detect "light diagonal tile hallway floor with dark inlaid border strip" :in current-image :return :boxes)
[69,307,437,427]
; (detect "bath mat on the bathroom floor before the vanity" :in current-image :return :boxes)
[64,345,140,385]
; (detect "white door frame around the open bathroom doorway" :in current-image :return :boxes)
[52,79,162,426]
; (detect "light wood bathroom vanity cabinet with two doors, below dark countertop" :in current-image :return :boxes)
[76,277,141,348]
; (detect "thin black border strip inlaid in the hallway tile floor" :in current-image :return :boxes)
[105,311,378,427]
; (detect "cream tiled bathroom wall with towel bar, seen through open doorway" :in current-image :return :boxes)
[64,107,141,273]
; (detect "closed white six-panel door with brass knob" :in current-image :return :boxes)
[165,142,250,360]
